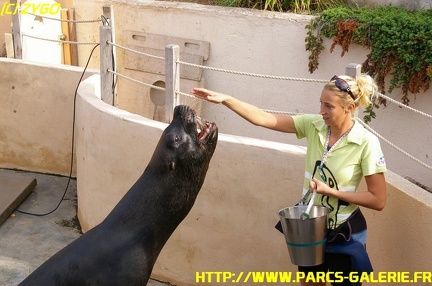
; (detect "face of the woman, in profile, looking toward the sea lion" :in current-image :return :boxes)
[320,89,351,126]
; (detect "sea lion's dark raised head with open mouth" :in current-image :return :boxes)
[149,105,218,190]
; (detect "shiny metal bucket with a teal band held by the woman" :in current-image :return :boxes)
[278,206,328,266]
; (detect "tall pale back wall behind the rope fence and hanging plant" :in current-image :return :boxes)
[69,0,432,188]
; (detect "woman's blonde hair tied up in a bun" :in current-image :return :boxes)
[324,74,378,108]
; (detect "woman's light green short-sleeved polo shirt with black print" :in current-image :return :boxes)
[293,114,387,229]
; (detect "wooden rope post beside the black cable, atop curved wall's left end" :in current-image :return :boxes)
[99,25,114,105]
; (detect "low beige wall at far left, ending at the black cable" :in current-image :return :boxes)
[0,58,94,175]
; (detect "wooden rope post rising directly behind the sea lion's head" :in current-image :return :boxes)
[165,45,180,122]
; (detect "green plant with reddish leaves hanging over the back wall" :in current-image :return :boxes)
[305,6,432,110]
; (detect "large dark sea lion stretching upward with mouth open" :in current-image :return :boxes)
[20,105,218,286]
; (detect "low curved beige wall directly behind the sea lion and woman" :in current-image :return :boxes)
[77,76,432,285]
